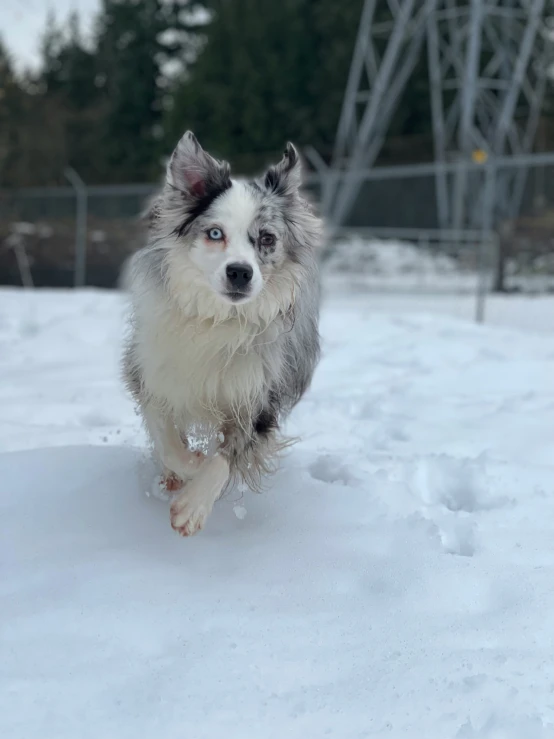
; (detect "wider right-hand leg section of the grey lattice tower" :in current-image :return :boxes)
[427,0,551,233]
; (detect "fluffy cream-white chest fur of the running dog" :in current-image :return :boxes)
[132,292,280,425]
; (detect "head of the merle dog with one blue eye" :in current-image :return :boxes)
[151,132,319,305]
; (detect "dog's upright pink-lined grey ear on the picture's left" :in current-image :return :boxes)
[166,131,231,200]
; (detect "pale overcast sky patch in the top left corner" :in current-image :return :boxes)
[0,0,100,68]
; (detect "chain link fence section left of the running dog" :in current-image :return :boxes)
[0,185,157,287]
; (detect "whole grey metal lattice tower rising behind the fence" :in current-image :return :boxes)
[324,0,552,228]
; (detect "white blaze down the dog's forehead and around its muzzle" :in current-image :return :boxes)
[191,180,263,299]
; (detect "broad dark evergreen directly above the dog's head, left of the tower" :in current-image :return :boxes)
[167,0,362,170]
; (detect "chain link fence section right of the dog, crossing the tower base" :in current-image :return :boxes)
[310,154,554,300]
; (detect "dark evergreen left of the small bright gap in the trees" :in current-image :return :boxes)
[96,0,203,182]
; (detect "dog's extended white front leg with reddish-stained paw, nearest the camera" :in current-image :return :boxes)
[171,454,229,536]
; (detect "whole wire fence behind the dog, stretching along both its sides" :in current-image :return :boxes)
[0,155,554,315]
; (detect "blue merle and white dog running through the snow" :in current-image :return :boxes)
[123,131,323,536]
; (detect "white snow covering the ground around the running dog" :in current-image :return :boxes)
[0,284,554,739]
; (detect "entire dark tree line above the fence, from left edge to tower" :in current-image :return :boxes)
[0,0,548,188]
